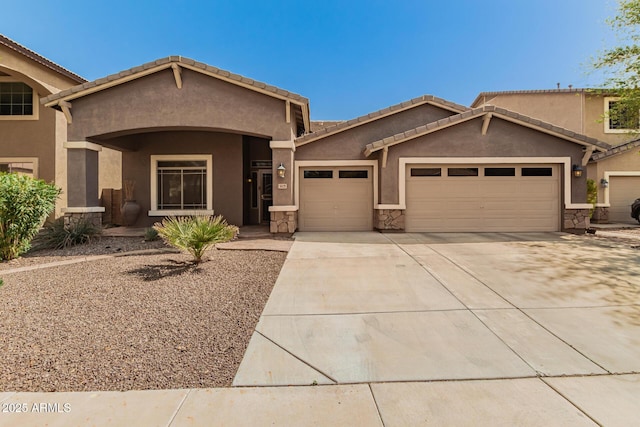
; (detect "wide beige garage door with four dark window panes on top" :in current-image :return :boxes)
[405,164,560,232]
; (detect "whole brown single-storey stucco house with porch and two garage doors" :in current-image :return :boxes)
[42,56,611,236]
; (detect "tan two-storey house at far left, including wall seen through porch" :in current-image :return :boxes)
[0,35,120,216]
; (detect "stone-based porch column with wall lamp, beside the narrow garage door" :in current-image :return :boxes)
[269,140,298,233]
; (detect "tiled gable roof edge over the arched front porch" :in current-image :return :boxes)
[41,56,309,104]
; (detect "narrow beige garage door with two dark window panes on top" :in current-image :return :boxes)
[298,166,373,231]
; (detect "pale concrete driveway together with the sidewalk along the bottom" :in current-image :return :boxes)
[0,233,640,426]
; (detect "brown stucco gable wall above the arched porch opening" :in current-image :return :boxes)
[69,69,291,140]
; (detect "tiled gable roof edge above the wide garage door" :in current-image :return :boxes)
[365,105,611,156]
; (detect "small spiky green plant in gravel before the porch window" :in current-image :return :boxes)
[153,215,238,264]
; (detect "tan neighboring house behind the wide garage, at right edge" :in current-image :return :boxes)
[472,89,640,226]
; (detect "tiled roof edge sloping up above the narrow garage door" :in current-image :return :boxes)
[296,95,469,145]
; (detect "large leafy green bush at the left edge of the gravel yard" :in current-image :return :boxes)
[0,173,60,260]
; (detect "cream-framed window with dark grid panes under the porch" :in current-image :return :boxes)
[150,155,213,215]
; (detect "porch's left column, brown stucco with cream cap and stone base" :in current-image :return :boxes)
[63,141,104,226]
